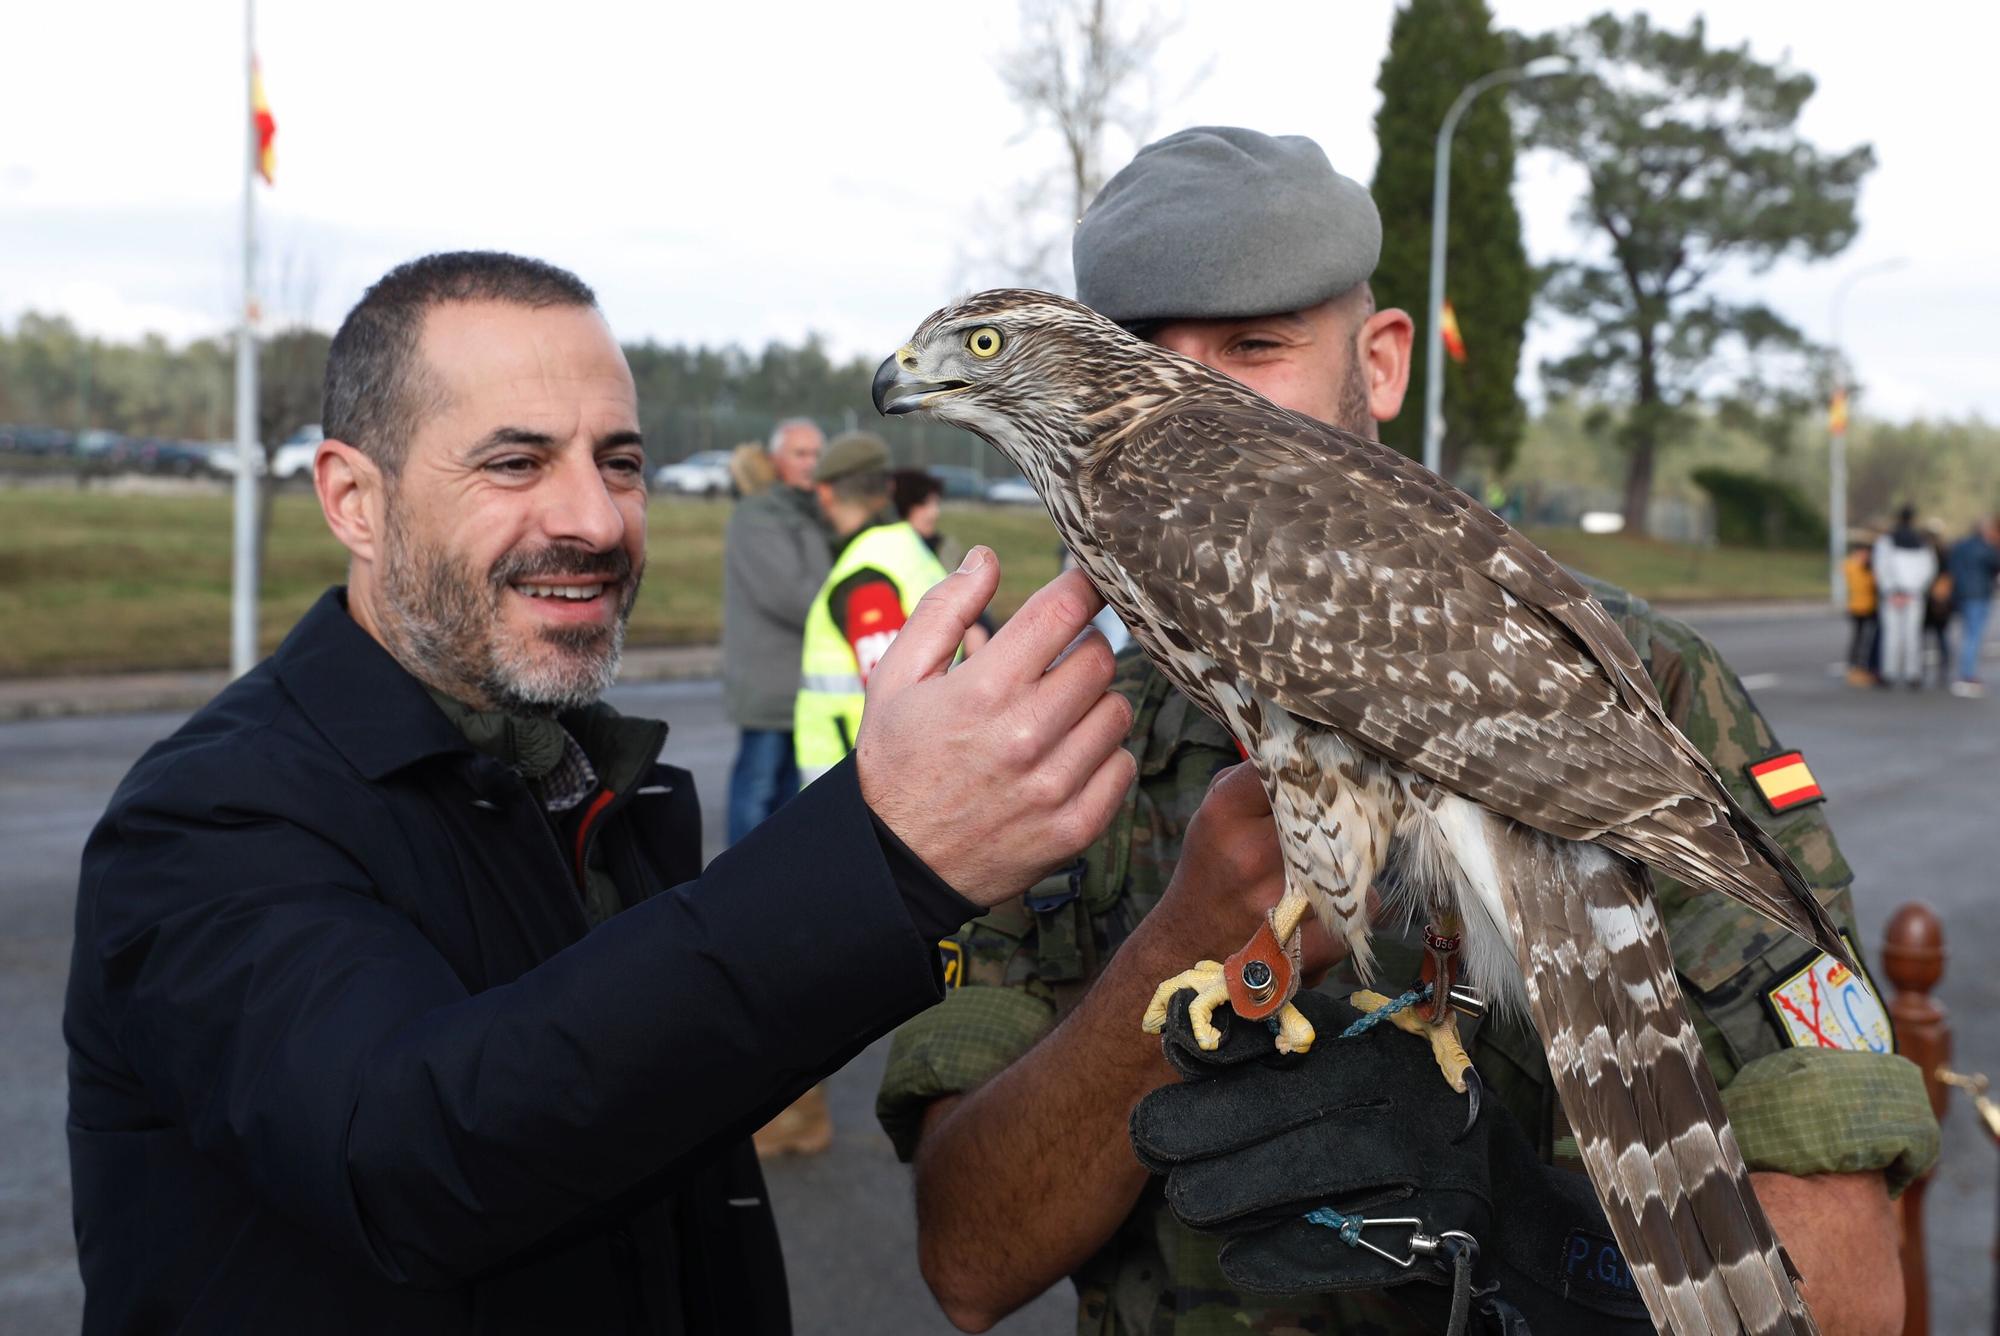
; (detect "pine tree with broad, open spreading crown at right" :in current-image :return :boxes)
[1512,14,1874,532]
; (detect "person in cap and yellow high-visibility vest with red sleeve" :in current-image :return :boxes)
[792,432,968,784]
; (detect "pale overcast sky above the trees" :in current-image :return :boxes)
[0,0,2000,418]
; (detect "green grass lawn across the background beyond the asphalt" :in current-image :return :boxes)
[0,488,1826,676]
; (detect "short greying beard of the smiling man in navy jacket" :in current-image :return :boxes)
[366,502,646,714]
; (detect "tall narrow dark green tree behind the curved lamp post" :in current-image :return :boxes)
[1374,0,1534,476]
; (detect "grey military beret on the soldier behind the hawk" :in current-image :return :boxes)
[1070,126,1382,324]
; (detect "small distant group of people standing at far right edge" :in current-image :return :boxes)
[1844,506,2000,698]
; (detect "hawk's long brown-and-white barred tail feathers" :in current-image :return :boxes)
[1488,816,1818,1336]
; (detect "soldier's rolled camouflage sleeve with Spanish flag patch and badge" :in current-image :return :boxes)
[1592,586,1938,1192]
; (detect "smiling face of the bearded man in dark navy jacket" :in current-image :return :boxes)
[378,302,646,710]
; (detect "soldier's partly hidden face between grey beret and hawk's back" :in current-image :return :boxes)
[1152,294,1410,438]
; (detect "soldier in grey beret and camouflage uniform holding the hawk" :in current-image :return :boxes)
[878,128,1938,1336]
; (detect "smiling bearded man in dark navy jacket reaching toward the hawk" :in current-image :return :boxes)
[64,254,1132,1336]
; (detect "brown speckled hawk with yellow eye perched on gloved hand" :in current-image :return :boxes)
[874,290,1848,1336]
